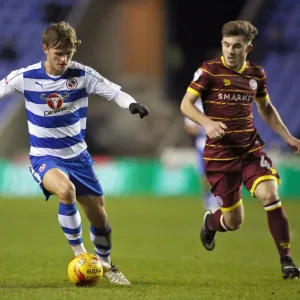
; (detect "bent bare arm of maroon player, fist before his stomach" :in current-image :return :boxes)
[180,91,227,140]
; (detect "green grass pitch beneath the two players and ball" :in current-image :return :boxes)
[0,197,300,300]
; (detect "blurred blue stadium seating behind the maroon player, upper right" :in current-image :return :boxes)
[254,0,300,150]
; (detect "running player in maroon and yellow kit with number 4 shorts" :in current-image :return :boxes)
[181,21,300,279]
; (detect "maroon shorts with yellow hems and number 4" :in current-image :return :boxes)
[204,150,280,211]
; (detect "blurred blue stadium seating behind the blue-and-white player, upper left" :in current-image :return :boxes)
[0,0,85,133]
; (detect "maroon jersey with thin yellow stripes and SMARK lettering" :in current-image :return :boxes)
[188,56,268,160]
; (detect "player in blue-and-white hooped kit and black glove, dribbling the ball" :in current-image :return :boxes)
[0,22,149,285]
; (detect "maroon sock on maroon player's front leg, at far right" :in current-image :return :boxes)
[265,200,290,257]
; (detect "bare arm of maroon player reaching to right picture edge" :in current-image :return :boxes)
[256,98,300,154]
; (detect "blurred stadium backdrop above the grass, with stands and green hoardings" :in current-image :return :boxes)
[0,0,300,197]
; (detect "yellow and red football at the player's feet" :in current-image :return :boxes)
[68,253,103,286]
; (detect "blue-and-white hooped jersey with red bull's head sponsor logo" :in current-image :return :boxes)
[0,61,121,159]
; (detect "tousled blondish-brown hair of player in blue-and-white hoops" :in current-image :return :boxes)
[42,22,81,50]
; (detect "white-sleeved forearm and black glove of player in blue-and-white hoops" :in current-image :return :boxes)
[112,91,149,119]
